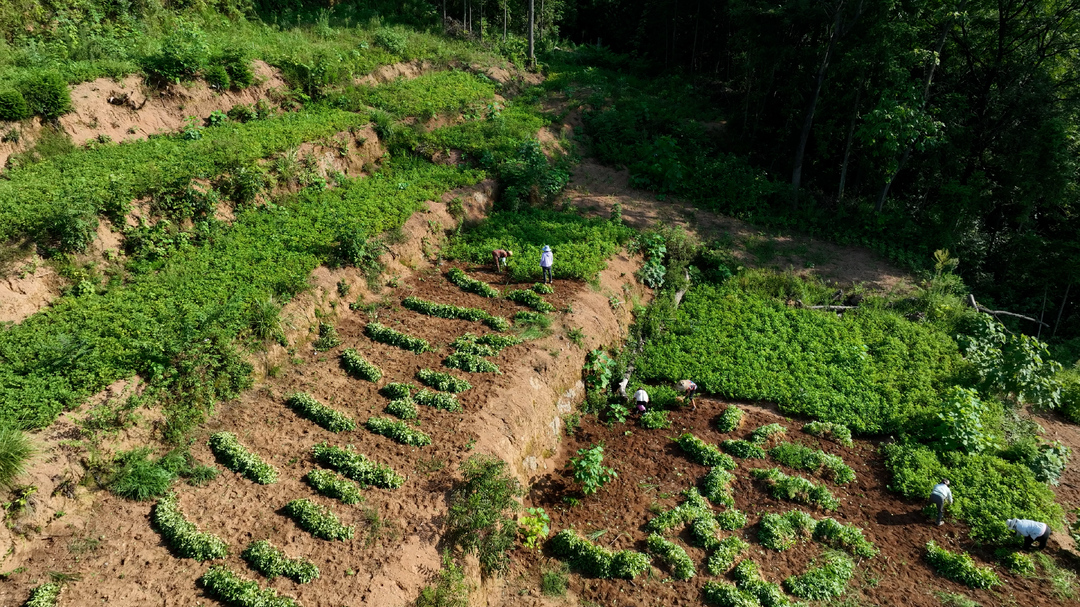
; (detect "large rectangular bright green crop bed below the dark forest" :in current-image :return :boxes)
[635,282,959,433]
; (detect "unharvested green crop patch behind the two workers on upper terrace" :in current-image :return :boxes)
[444,208,630,280]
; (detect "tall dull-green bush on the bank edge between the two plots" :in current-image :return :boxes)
[446,455,522,575]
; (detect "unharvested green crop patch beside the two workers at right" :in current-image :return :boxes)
[882,444,1063,542]
